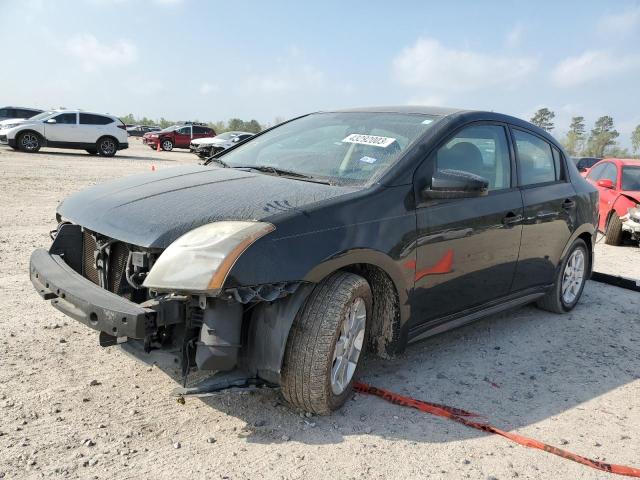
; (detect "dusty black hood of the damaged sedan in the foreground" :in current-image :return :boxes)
[58,165,354,248]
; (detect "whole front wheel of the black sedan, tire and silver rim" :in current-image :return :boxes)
[282,272,372,414]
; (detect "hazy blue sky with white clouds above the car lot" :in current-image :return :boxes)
[0,0,640,146]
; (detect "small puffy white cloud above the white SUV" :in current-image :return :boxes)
[63,33,138,72]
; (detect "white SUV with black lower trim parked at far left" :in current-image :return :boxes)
[0,110,129,157]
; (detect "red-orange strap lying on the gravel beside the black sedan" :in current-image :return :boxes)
[353,382,640,478]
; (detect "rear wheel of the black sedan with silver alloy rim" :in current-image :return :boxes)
[538,238,591,313]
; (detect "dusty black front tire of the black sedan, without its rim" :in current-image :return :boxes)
[282,272,372,415]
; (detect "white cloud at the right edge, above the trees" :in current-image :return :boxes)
[551,50,640,87]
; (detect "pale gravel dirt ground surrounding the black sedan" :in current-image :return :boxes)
[0,140,640,479]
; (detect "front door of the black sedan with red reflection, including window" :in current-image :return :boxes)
[414,123,523,326]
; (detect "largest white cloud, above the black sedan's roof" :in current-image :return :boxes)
[393,38,537,92]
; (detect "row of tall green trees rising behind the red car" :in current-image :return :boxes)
[530,108,640,158]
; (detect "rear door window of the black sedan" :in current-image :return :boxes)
[513,130,561,185]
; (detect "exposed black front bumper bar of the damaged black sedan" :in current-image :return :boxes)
[29,249,157,339]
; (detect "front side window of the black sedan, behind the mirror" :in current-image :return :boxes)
[435,125,511,190]
